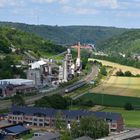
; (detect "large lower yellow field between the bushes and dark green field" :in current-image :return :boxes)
[90,76,140,97]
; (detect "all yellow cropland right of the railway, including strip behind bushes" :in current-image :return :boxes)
[90,59,140,97]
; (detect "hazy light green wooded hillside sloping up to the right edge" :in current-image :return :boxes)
[98,29,140,53]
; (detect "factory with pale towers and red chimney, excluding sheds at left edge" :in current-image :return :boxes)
[27,43,82,88]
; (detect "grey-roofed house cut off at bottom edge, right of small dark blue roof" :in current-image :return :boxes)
[31,132,60,140]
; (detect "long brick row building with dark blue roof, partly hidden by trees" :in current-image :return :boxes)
[8,106,124,132]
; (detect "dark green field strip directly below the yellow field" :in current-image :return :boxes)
[80,93,140,109]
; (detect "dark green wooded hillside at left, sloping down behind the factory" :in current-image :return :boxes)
[0,27,65,54]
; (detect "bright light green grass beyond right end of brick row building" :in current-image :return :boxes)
[102,107,140,128]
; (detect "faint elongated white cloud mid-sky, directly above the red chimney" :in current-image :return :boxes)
[62,6,98,15]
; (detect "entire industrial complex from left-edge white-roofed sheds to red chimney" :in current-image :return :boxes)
[0,42,82,98]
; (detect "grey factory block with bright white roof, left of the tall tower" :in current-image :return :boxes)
[27,60,56,88]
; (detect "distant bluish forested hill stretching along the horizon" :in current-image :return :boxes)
[0,22,128,45]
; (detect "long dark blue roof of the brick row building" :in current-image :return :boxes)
[11,106,121,121]
